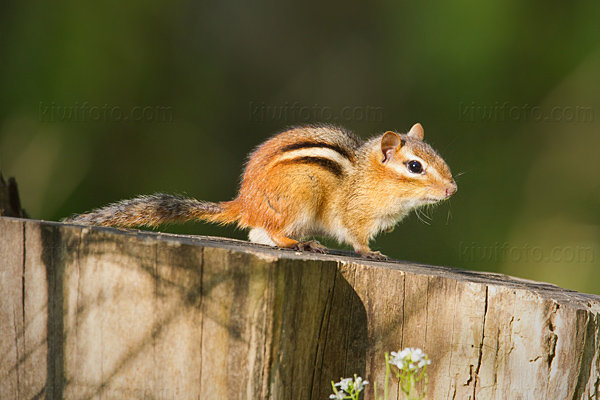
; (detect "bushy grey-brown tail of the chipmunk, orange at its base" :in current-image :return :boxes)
[63,193,240,228]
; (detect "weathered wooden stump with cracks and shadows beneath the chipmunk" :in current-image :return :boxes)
[0,218,600,399]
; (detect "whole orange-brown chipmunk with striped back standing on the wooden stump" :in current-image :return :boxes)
[64,124,457,260]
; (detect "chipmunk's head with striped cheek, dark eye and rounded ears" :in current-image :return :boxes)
[380,124,457,208]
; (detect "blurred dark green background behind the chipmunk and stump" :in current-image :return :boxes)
[0,0,600,293]
